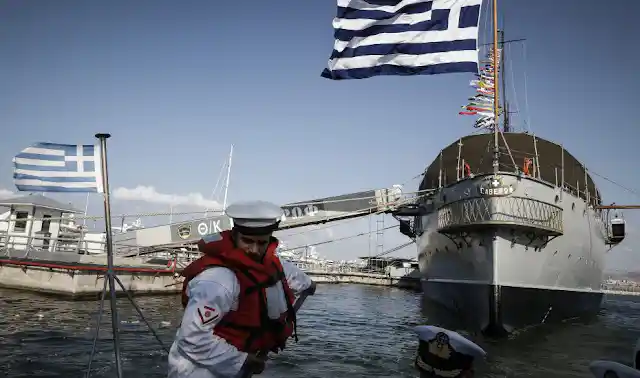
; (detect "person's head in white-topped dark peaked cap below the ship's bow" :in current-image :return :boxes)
[415,326,486,378]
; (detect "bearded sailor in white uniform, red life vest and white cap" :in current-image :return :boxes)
[168,201,315,378]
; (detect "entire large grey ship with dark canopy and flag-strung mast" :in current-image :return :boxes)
[395,0,626,335]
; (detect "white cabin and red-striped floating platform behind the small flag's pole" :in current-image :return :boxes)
[0,194,178,299]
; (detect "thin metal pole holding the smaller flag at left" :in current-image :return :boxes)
[96,134,122,378]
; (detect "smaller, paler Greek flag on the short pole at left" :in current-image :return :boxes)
[13,143,103,193]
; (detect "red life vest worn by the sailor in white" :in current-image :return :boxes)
[182,231,298,353]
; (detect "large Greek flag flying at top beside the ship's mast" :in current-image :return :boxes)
[322,0,482,80]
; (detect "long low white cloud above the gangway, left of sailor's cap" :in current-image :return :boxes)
[112,185,222,210]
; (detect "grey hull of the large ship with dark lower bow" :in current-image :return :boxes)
[417,173,605,334]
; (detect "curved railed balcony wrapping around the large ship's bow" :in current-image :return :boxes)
[438,196,563,235]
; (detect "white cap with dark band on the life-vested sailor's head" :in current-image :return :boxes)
[225,201,284,233]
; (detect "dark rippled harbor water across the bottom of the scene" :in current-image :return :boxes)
[0,285,640,378]
